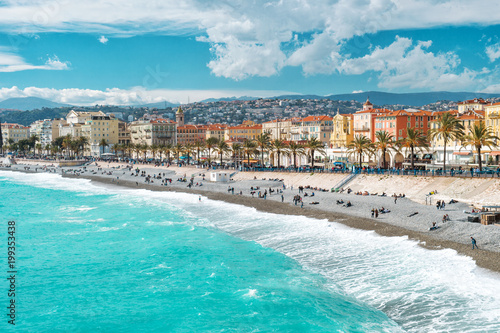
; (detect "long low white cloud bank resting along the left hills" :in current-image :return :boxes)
[0,86,295,105]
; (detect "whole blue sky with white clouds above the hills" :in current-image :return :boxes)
[0,0,500,104]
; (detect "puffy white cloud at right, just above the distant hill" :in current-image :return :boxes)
[337,37,479,90]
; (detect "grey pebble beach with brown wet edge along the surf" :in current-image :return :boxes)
[0,165,500,273]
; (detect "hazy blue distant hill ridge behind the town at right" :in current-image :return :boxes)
[275,91,500,106]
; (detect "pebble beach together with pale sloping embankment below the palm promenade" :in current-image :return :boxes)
[3,161,500,272]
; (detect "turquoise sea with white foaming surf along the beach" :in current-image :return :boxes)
[0,171,500,332]
